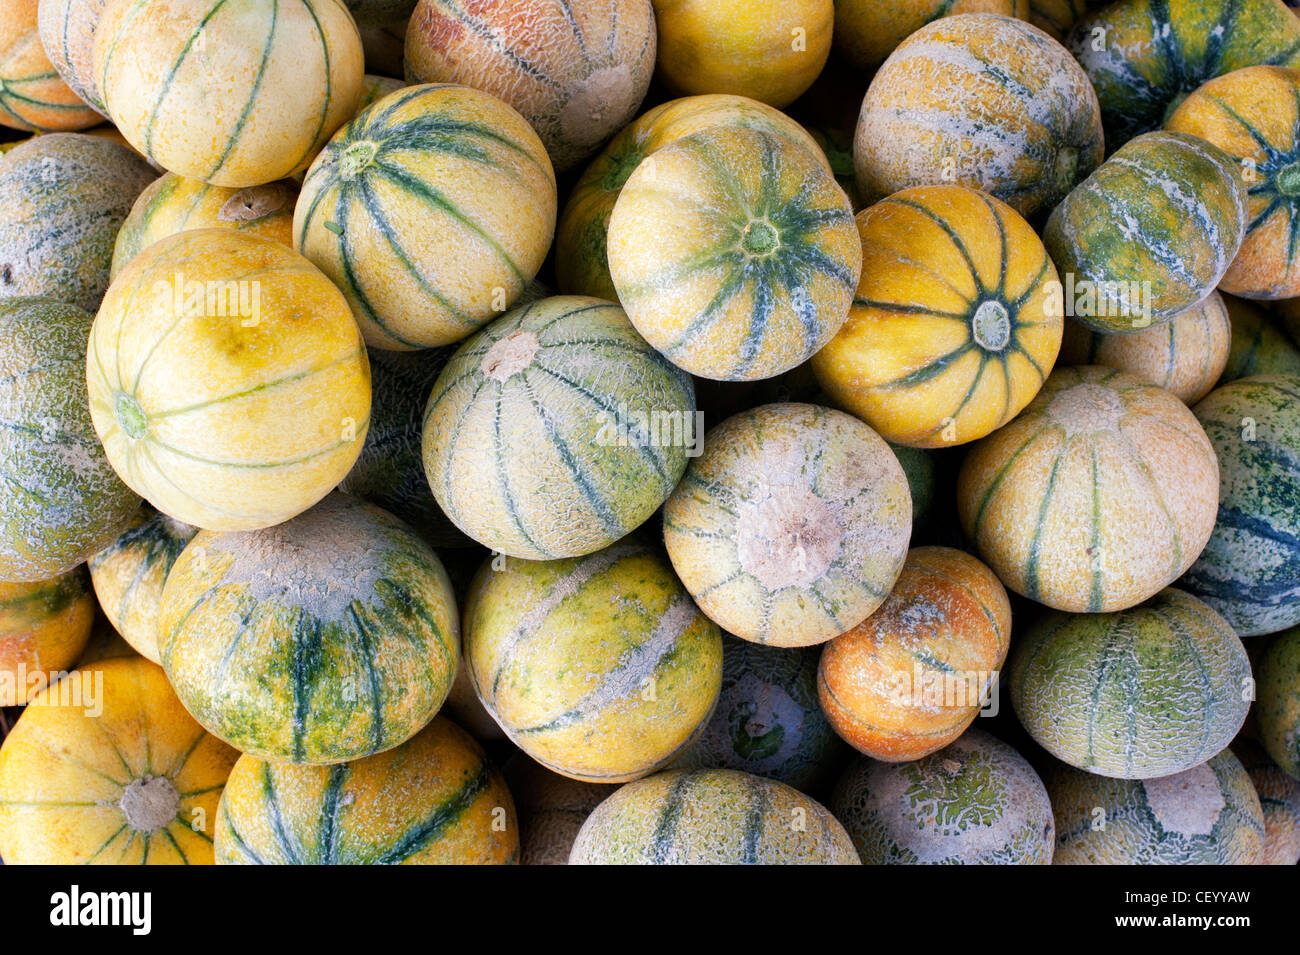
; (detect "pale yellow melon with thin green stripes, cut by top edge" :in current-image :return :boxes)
[92,0,364,188]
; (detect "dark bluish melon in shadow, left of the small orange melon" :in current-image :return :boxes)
[672,635,848,795]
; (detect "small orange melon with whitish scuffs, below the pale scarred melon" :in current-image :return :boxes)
[818,547,1011,763]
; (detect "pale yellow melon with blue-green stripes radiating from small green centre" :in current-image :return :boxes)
[608,127,862,381]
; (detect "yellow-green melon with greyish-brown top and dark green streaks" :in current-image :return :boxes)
[159,494,459,764]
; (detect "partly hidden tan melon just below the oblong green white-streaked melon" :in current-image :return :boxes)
[1058,292,1238,404]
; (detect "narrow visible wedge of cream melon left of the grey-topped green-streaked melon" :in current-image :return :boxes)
[90,508,198,663]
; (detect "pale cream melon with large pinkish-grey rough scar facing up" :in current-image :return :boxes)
[663,404,911,647]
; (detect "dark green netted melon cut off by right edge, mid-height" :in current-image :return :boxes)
[1179,376,1300,637]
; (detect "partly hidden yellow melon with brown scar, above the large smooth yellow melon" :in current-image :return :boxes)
[112,173,298,278]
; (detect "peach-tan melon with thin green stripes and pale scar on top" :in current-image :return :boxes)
[957,366,1218,613]
